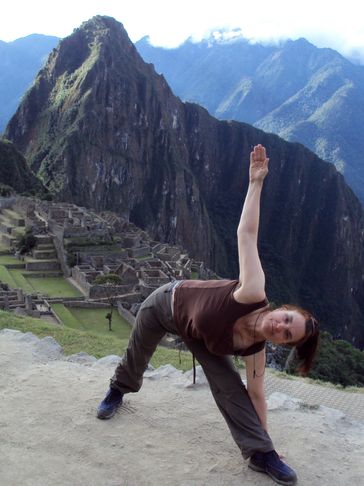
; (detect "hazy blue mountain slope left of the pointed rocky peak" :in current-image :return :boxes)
[0,34,59,133]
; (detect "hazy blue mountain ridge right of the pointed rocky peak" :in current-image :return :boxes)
[136,33,364,203]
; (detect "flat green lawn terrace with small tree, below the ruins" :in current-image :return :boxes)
[52,304,131,339]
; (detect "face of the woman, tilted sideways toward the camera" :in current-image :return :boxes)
[261,309,306,344]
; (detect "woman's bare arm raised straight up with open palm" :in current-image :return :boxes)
[234,145,269,303]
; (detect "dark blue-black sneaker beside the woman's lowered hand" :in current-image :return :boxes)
[248,451,297,486]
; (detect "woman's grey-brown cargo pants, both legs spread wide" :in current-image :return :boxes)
[111,283,274,458]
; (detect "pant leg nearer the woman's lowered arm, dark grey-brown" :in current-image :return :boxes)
[186,340,274,459]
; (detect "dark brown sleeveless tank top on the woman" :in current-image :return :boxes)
[173,280,268,356]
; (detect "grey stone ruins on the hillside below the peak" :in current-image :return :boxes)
[0,196,216,332]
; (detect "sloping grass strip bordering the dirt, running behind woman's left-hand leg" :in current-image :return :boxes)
[0,311,192,371]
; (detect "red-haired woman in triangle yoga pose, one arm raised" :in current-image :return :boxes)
[97,145,318,485]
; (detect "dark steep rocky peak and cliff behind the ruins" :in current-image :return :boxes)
[6,17,364,345]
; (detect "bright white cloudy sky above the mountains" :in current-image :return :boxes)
[0,0,364,64]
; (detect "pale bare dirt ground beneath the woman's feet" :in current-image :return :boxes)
[0,330,364,486]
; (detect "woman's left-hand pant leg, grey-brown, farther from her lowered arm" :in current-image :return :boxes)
[110,283,174,393]
